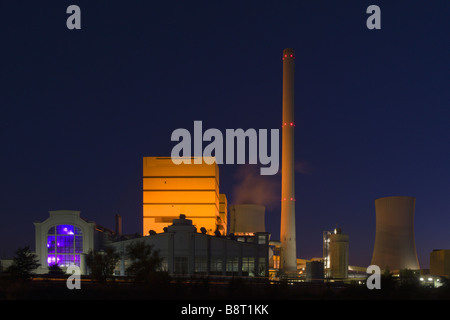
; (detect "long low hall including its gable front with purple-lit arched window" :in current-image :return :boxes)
[34,210,270,277]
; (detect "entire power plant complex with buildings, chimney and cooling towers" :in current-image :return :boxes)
[0,48,450,288]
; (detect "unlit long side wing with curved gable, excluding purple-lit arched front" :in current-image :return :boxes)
[110,215,270,277]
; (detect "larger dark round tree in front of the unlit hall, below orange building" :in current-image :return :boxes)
[126,241,166,283]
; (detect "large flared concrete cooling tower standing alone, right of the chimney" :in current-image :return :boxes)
[371,197,420,271]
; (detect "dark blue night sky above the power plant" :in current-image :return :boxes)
[0,0,450,268]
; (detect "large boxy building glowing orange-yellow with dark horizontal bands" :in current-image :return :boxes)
[143,157,226,235]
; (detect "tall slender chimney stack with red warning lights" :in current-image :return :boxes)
[280,48,297,273]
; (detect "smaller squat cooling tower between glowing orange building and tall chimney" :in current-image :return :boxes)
[230,204,266,234]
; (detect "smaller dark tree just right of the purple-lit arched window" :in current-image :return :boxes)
[86,247,120,282]
